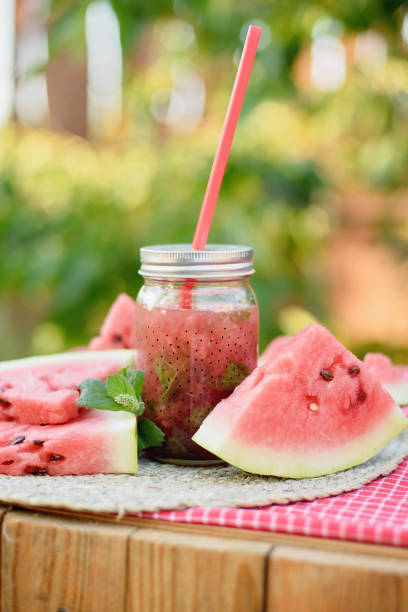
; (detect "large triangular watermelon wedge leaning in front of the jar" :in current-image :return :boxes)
[193,323,408,478]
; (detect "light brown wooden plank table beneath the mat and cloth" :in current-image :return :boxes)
[0,507,408,612]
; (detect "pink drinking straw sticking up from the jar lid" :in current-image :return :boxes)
[193,25,262,251]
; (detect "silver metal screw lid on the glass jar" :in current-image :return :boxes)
[140,244,254,280]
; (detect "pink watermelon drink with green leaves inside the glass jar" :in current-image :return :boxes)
[136,303,258,463]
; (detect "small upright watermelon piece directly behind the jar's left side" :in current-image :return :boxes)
[89,293,136,351]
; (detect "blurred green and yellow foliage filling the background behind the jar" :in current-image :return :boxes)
[0,0,408,358]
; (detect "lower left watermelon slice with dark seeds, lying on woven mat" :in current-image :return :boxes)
[0,410,137,476]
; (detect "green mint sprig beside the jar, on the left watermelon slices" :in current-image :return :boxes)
[77,368,164,452]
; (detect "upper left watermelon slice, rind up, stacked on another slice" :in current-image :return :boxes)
[0,350,134,425]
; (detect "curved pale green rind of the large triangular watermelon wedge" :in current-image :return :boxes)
[192,405,408,479]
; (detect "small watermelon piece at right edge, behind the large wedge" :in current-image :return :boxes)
[363,353,408,406]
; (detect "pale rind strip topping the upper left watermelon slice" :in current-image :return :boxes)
[0,349,136,372]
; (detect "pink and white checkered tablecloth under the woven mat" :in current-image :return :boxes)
[140,408,408,546]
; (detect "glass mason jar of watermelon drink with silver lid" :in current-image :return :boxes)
[136,244,258,465]
